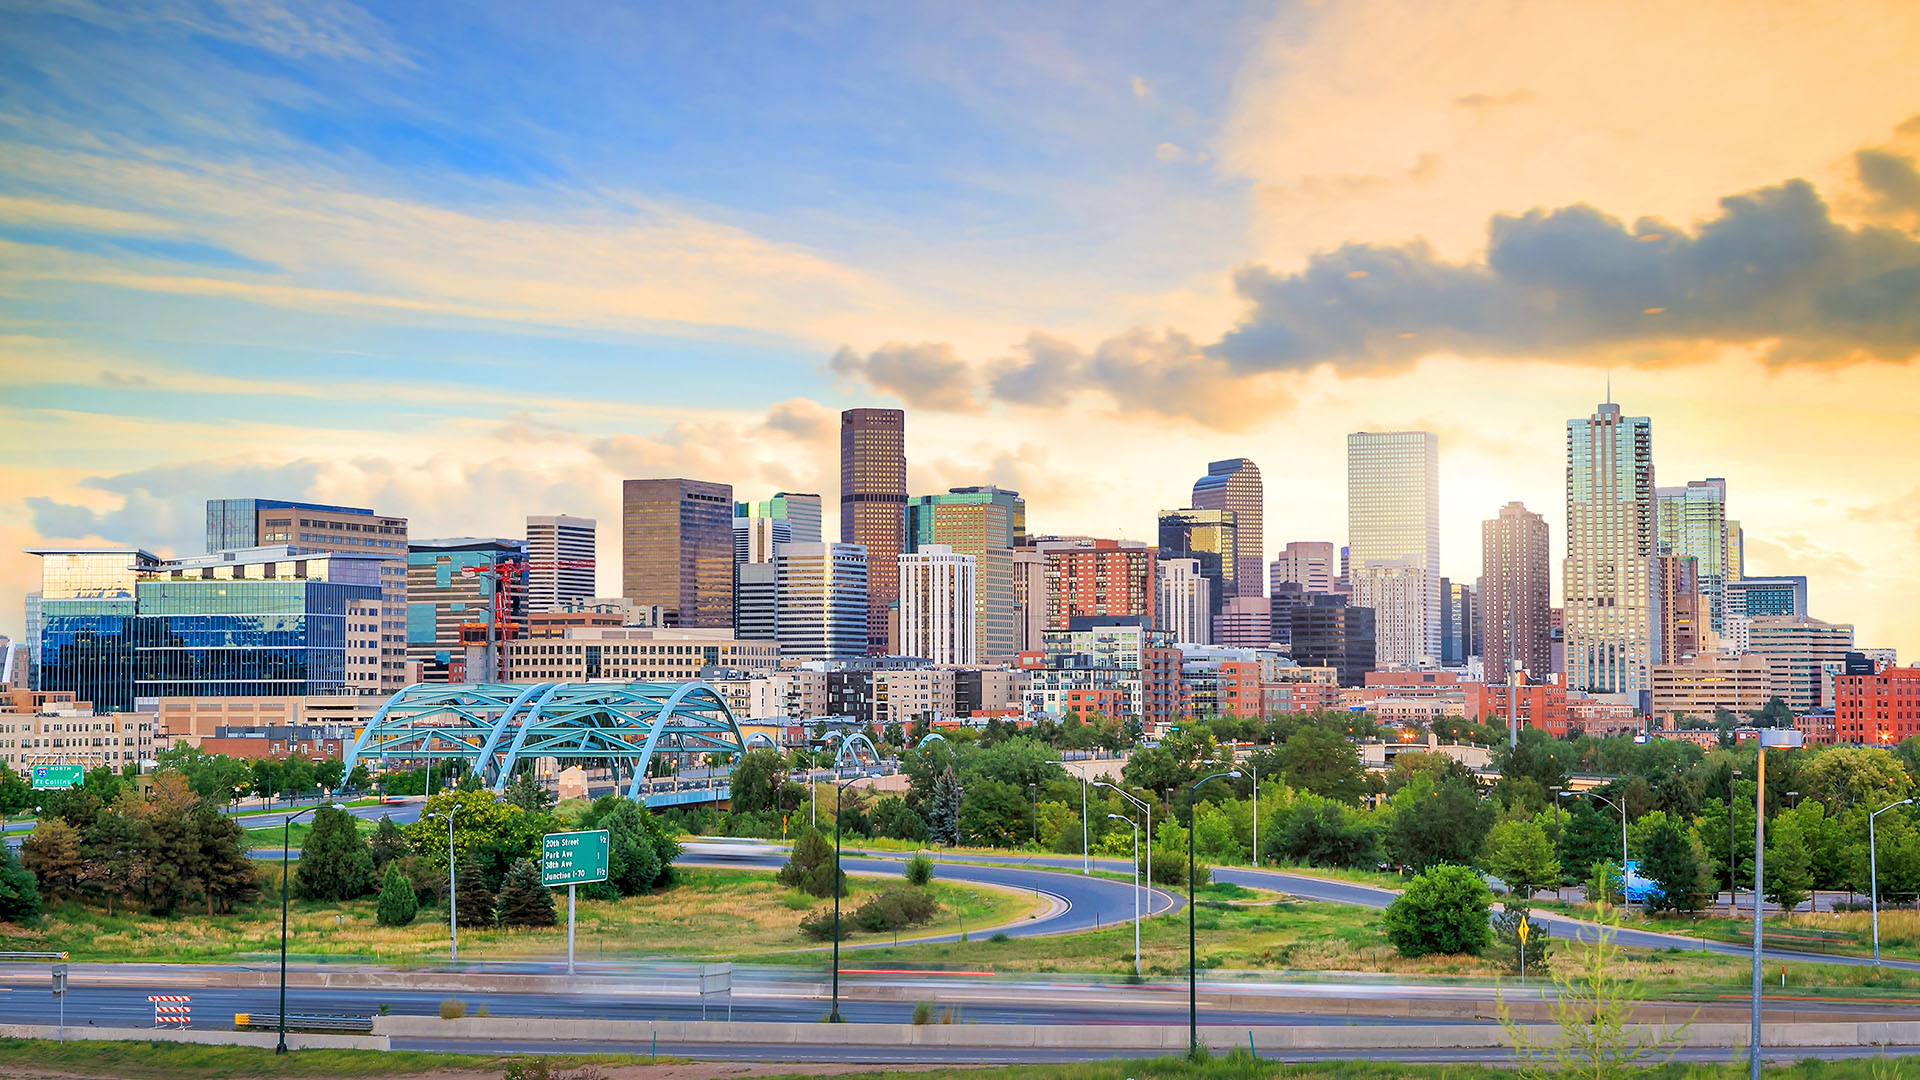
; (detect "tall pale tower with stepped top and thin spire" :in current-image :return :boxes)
[1561,402,1661,700]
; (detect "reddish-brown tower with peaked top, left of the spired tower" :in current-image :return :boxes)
[1480,502,1553,682]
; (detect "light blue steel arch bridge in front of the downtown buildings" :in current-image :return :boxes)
[346,680,745,805]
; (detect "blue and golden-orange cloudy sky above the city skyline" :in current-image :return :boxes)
[0,0,1920,645]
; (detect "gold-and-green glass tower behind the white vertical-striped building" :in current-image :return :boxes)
[906,486,1027,663]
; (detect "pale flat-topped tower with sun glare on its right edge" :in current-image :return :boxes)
[1346,430,1440,669]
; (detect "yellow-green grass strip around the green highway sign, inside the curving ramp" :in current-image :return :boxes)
[8,867,1037,967]
